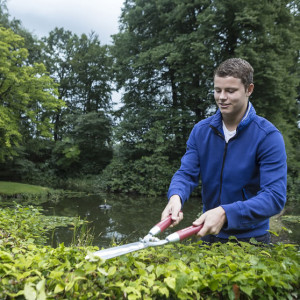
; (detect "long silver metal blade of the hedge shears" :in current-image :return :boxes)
[93,242,148,259]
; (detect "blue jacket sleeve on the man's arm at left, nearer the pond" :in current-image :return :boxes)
[168,127,200,204]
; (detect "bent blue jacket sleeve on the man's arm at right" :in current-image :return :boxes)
[222,131,287,230]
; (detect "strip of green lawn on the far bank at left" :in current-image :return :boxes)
[0,181,50,195]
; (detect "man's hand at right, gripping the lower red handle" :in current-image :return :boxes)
[193,206,227,237]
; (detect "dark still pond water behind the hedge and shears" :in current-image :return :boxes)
[42,194,300,248]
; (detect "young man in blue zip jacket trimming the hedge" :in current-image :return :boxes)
[162,58,287,243]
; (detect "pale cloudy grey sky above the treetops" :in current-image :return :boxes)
[7,0,124,45]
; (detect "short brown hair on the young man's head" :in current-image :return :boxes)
[214,58,254,89]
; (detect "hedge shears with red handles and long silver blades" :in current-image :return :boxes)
[86,215,203,259]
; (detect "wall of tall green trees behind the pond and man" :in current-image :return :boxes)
[0,0,300,201]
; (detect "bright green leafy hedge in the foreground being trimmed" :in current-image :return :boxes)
[0,207,300,300]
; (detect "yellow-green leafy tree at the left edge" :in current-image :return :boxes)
[0,27,63,161]
